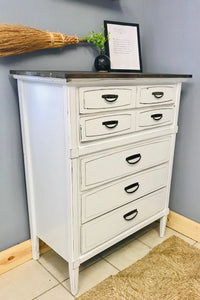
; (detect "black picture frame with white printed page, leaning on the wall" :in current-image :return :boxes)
[104,20,142,73]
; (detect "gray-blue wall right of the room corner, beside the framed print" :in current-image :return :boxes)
[143,0,200,222]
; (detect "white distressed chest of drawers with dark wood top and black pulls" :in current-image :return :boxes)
[11,71,190,294]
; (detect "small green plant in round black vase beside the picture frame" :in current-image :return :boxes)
[83,25,110,72]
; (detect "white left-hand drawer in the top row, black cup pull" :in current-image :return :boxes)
[79,87,136,113]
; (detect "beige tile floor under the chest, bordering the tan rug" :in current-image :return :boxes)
[0,222,200,300]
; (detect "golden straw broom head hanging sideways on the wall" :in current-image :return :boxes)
[0,24,85,57]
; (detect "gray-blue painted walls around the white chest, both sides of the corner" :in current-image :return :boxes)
[0,0,200,251]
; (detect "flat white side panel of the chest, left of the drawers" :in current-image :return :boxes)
[17,82,70,259]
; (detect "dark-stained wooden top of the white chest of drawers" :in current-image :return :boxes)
[10,70,192,80]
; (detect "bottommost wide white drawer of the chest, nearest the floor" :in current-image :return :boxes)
[81,189,167,253]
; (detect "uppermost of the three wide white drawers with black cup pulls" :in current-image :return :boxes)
[81,139,171,190]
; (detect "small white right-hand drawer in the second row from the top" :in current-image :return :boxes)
[136,107,175,130]
